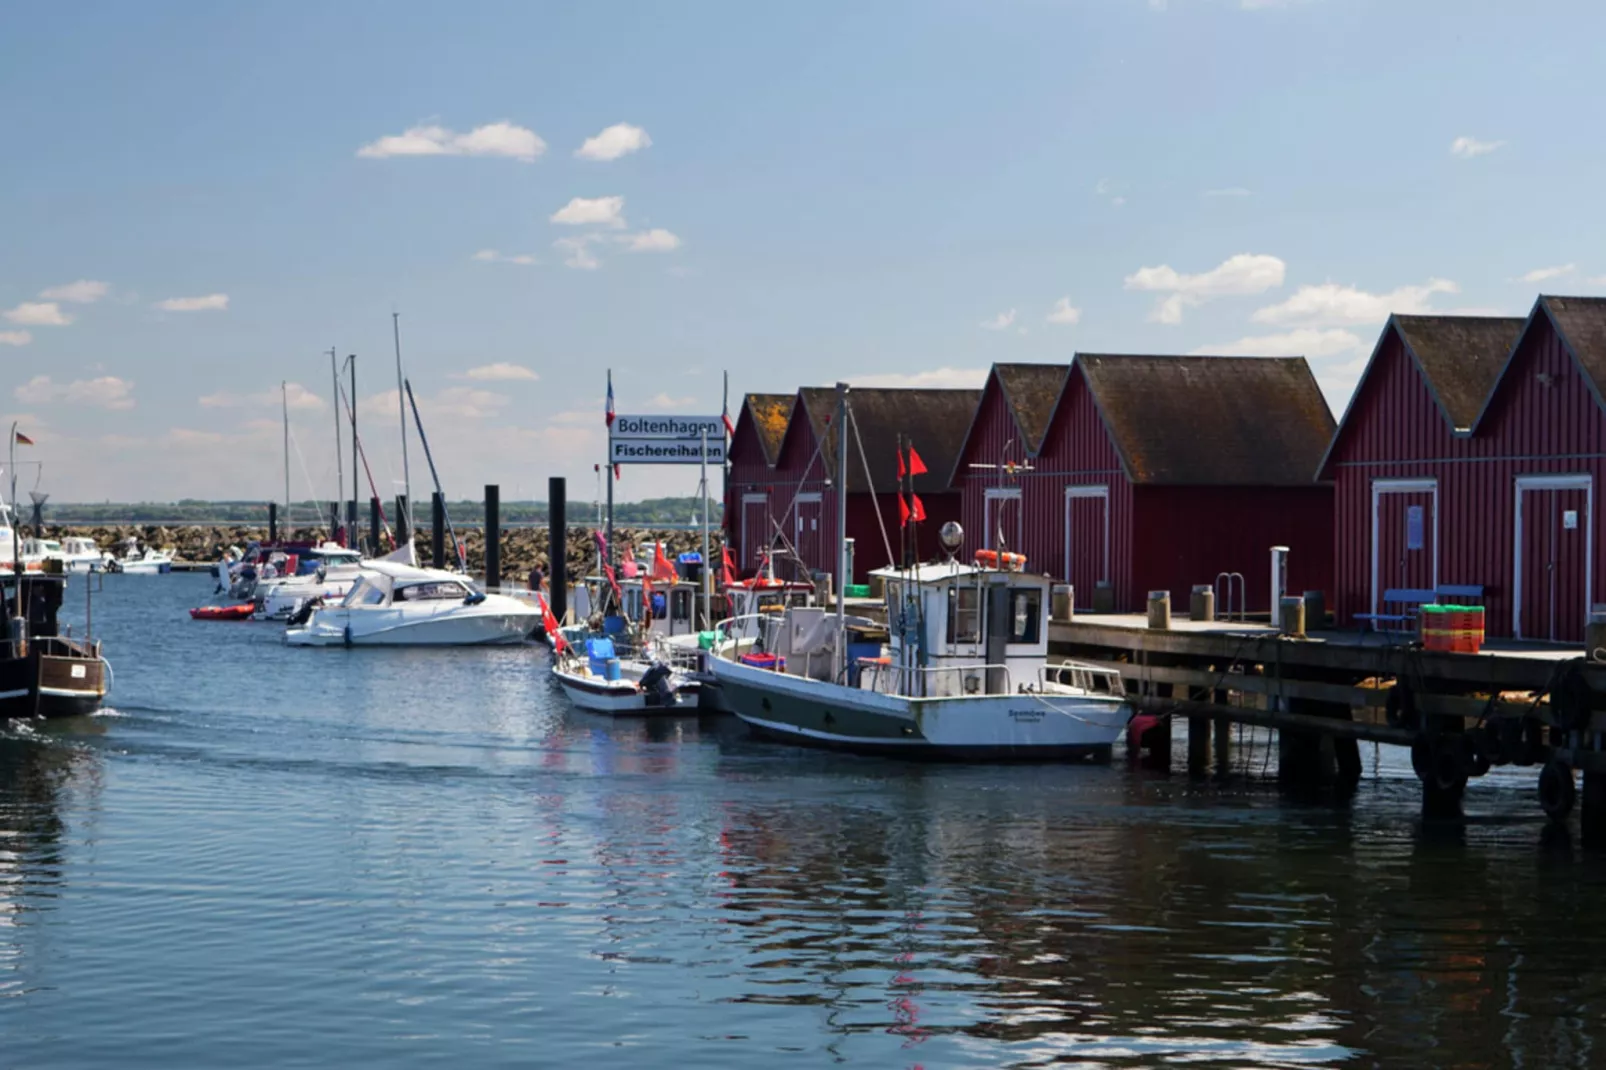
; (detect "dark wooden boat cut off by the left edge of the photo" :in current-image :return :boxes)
[0,572,111,718]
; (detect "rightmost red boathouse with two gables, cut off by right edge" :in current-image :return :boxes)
[1322,297,1606,643]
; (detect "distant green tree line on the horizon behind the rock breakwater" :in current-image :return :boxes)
[43,498,724,527]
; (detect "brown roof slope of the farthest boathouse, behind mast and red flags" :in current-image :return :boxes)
[798,387,981,493]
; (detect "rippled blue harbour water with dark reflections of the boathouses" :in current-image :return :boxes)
[0,575,1606,1068]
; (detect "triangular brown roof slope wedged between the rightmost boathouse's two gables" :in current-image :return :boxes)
[1392,315,1524,431]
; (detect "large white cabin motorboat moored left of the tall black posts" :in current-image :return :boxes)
[284,561,541,646]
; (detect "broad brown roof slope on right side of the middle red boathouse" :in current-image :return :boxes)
[1076,353,1335,487]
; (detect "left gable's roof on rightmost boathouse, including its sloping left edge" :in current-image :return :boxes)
[1317,313,1524,479]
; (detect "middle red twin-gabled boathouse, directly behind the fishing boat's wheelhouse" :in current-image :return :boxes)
[954,353,1333,612]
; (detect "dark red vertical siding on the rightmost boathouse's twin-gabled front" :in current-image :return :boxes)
[1330,310,1606,639]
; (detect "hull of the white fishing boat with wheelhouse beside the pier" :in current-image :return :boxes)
[710,657,1127,762]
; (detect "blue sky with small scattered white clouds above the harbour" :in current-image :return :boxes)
[0,0,1606,501]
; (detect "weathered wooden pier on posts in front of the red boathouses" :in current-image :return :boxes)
[1049,614,1606,819]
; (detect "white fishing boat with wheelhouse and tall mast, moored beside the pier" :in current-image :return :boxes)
[708,386,1131,760]
